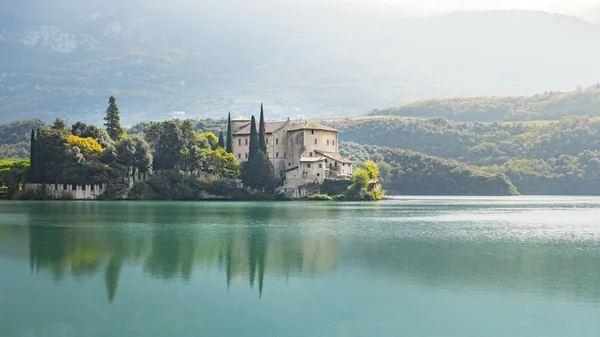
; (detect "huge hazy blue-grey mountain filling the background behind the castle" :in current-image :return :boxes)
[0,0,600,124]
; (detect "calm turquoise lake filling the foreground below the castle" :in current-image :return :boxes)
[0,197,600,337]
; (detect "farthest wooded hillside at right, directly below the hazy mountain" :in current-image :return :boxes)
[372,84,600,122]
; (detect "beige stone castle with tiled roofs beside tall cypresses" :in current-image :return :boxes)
[231,117,354,196]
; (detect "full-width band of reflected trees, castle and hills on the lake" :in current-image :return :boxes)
[0,203,600,302]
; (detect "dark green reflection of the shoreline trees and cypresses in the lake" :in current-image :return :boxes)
[21,201,338,302]
